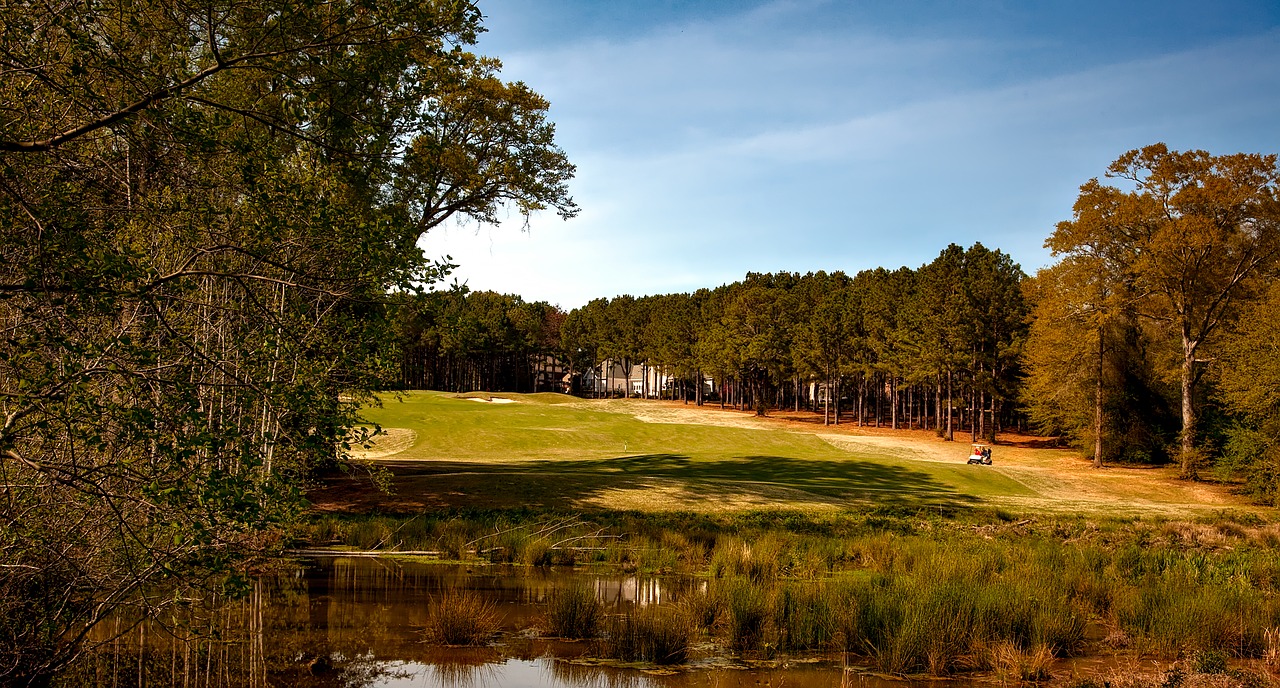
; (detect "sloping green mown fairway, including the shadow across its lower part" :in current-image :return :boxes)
[348,393,1037,510]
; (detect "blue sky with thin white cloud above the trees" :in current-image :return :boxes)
[422,0,1280,309]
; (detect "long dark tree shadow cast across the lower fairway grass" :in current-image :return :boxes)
[312,454,980,512]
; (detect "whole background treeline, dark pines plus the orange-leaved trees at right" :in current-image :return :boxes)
[396,145,1280,503]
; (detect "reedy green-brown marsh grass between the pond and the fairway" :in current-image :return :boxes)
[294,509,1280,676]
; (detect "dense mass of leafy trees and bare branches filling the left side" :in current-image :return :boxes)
[0,0,576,684]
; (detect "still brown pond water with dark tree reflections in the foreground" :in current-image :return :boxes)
[63,558,1131,688]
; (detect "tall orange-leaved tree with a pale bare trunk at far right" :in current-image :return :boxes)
[1047,143,1280,477]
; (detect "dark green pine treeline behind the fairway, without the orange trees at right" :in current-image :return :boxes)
[402,244,1028,437]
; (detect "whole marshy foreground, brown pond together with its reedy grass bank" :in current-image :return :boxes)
[61,517,1280,688]
